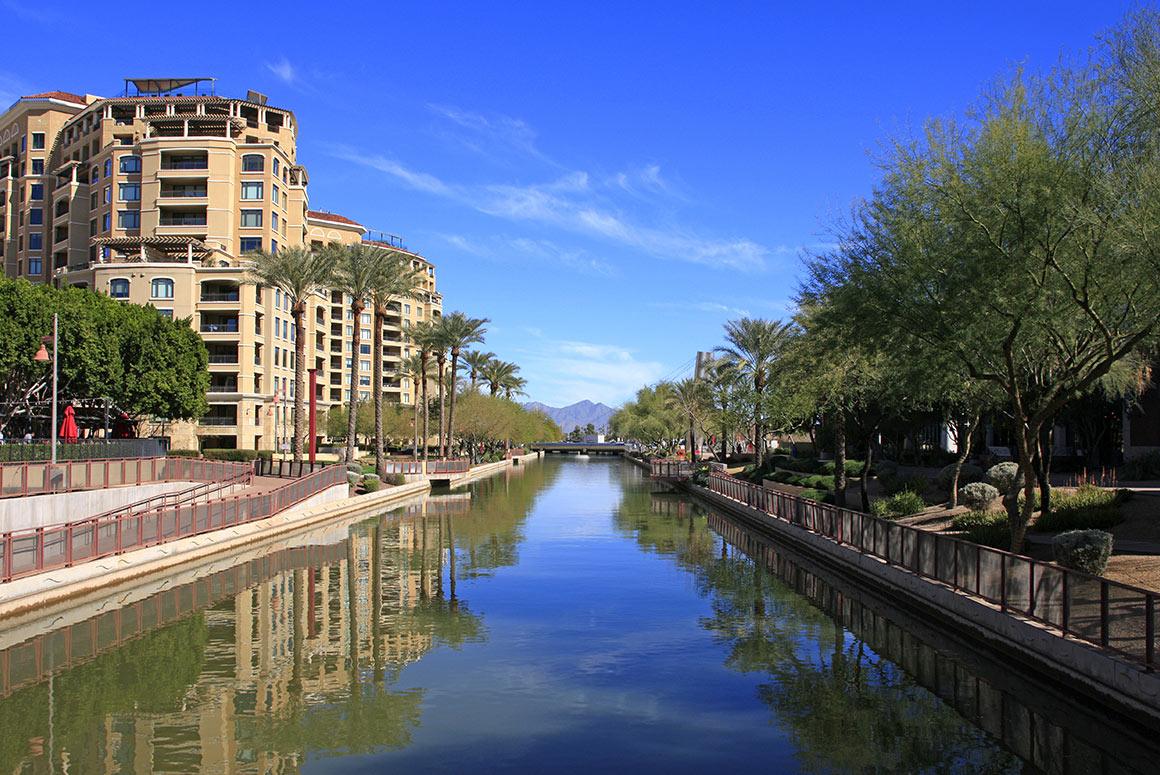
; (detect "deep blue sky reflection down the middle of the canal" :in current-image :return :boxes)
[304,461,796,773]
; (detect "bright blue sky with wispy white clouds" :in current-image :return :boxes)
[0,0,1132,406]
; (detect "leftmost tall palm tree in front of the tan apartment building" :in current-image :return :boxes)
[246,246,333,461]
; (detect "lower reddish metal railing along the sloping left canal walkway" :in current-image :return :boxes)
[0,466,346,582]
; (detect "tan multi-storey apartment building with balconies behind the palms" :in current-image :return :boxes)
[0,79,442,449]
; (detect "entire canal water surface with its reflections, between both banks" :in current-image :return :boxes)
[0,458,1160,775]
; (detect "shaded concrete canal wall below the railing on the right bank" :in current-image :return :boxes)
[682,484,1160,720]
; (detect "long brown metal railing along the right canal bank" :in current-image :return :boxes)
[709,471,1160,669]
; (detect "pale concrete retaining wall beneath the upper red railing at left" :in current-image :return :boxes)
[0,481,203,531]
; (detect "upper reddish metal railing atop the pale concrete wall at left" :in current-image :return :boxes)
[0,457,248,498]
